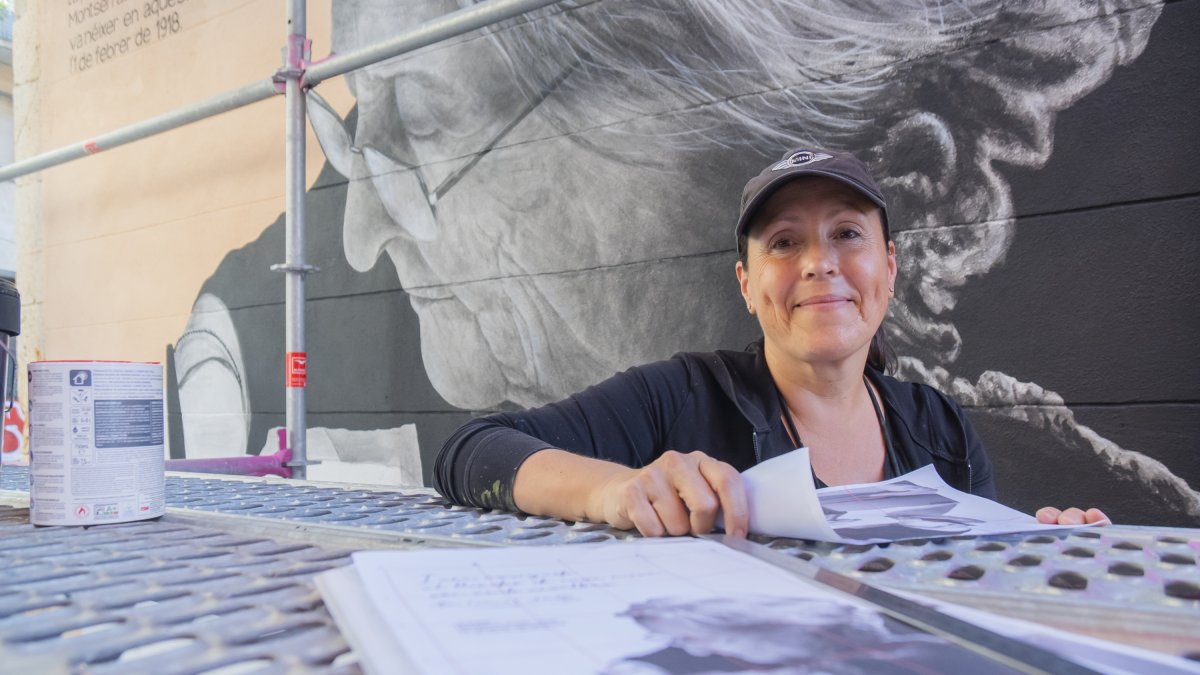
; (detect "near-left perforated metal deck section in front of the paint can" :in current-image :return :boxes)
[0,506,358,674]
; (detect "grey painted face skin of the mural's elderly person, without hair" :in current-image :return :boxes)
[318,2,750,408]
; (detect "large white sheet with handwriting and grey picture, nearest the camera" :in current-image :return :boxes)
[336,539,1007,675]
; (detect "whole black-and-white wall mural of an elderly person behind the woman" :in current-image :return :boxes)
[173,0,1200,526]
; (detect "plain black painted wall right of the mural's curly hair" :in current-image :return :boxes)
[955,0,1200,526]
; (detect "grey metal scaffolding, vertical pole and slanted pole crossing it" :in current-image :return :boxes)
[0,0,560,478]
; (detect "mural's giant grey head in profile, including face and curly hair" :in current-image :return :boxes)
[313,0,1159,408]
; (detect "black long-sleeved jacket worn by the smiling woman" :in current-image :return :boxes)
[433,344,996,510]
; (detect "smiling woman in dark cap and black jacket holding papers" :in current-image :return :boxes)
[434,149,1105,536]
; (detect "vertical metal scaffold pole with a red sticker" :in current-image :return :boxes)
[283,0,313,478]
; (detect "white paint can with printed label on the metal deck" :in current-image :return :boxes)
[29,362,166,525]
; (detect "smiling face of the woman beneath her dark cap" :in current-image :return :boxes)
[737,177,896,363]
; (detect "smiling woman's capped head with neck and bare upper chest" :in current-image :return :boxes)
[737,168,896,484]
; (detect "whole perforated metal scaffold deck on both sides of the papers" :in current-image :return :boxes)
[0,467,1200,673]
